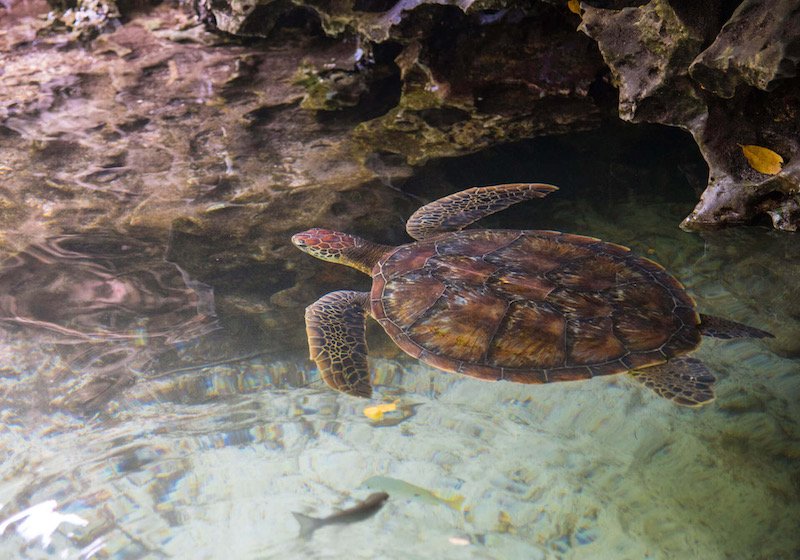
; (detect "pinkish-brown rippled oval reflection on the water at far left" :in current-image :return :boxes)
[0,234,214,345]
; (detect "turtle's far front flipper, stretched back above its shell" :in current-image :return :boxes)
[406,183,558,240]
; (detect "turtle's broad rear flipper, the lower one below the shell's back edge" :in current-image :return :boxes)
[631,358,716,406]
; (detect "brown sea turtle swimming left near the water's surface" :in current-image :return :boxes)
[292,183,772,406]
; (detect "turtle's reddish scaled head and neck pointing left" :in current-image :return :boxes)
[292,228,388,274]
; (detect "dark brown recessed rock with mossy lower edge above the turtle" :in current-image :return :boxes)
[355,4,603,165]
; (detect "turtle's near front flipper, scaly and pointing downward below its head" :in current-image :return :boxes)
[306,290,372,397]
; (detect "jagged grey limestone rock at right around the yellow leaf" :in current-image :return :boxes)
[581,0,800,231]
